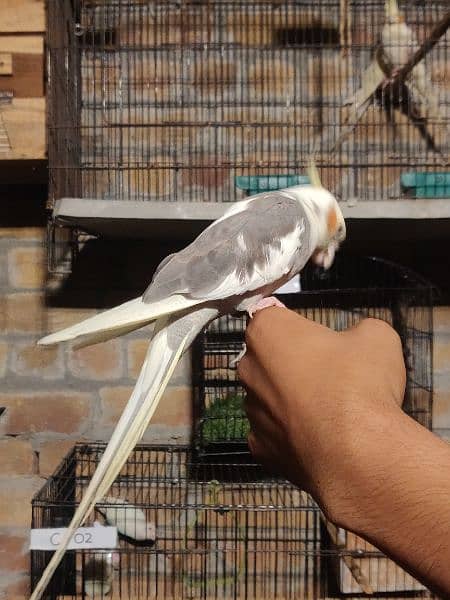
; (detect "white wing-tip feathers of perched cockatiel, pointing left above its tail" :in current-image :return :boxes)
[38,295,201,347]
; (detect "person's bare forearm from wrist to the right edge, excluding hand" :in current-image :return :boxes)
[331,415,450,598]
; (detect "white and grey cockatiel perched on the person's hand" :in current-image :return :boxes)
[31,170,346,600]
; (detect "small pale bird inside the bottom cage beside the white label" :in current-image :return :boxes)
[95,496,156,544]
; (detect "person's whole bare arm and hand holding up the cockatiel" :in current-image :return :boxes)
[238,308,450,598]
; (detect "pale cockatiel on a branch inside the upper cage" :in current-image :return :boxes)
[330,0,445,154]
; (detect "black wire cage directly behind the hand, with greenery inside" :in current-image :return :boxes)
[193,255,433,460]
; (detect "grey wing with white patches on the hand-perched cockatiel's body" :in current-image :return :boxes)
[143,191,312,302]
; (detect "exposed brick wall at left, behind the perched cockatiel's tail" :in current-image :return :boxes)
[0,217,191,598]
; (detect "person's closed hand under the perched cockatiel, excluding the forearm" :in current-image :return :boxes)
[238,308,406,523]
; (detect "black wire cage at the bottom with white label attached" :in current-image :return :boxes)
[31,444,438,600]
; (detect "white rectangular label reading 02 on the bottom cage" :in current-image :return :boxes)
[30,526,117,550]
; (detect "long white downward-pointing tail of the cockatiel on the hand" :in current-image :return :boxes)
[30,317,190,600]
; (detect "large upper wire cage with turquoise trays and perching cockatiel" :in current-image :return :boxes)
[47,0,450,264]
